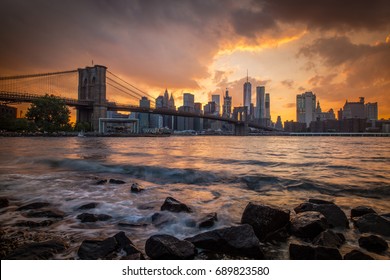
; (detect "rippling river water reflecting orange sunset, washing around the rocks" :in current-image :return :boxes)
[0,136,390,258]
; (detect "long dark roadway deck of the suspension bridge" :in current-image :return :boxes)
[0,91,275,131]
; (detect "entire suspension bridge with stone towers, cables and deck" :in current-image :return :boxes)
[0,65,274,135]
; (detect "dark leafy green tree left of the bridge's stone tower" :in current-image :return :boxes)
[26,94,71,132]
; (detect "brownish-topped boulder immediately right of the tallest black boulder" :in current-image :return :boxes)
[291,211,329,239]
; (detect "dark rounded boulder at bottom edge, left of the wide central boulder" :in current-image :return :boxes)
[145,234,196,260]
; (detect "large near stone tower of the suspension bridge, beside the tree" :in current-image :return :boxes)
[77,65,107,131]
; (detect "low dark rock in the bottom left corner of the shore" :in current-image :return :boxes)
[5,240,66,260]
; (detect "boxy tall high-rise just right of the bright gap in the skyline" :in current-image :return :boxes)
[296,91,316,127]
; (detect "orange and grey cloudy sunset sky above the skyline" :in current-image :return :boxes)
[0,0,390,121]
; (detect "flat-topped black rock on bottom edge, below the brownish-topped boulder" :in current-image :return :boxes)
[289,243,342,260]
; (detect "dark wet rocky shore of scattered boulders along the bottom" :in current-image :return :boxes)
[0,182,390,260]
